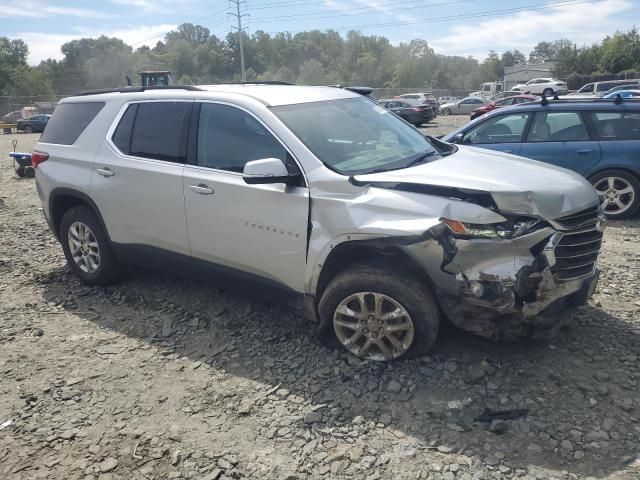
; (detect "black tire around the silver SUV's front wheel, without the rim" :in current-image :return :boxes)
[318,264,440,358]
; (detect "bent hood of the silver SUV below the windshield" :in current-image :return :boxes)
[355,146,598,220]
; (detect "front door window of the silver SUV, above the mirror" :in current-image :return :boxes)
[197,103,288,172]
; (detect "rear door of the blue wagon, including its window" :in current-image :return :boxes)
[520,111,602,175]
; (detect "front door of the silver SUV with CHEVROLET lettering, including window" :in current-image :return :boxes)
[184,102,309,292]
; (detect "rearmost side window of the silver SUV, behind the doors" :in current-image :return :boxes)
[40,102,104,145]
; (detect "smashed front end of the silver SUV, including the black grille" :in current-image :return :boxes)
[405,207,604,339]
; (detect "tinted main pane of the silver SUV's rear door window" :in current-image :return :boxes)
[130,102,192,163]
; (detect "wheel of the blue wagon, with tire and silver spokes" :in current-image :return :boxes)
[589,170,640,219]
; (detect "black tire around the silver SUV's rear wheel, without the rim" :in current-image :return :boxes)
[60,205,121,285]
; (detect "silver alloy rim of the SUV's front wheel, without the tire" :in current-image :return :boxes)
[333,292,414,361]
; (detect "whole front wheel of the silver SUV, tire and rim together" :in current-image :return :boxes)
[318,264,440,361]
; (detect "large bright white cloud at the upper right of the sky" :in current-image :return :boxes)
[431,0,635,58]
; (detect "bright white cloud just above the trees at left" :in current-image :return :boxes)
[12,24,176,65]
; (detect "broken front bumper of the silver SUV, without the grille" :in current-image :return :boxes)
[407,223,602,339]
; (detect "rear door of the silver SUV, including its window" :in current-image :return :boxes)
[90,100,193,255]
